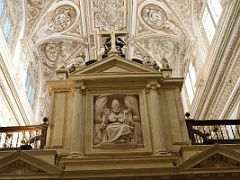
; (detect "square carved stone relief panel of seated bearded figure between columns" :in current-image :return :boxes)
[94,95,143,146]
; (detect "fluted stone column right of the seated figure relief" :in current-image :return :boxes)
[146,81,167,155]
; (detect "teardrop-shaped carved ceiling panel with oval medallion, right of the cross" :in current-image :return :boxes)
[141,4,182,34]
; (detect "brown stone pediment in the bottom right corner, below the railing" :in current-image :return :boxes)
[178,145,240,170]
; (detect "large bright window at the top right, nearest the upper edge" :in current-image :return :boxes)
[202,0,222,43]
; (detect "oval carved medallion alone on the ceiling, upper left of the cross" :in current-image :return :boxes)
[48,5,77,32]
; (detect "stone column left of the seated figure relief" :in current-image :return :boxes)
[71,85,86,157]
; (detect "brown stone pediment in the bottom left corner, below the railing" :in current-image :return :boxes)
[0,151,62,177]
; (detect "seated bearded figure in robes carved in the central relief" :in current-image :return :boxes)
[101,99,133,143]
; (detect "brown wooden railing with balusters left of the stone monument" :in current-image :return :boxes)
[0,118,48,151]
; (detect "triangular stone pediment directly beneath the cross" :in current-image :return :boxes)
[70,55,159,76]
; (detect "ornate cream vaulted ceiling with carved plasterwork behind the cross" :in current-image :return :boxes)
[25,0,201,82]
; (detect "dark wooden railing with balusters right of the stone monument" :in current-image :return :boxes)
[186,119,240,145]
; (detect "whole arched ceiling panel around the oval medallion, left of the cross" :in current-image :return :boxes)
[31,1,81,40]
